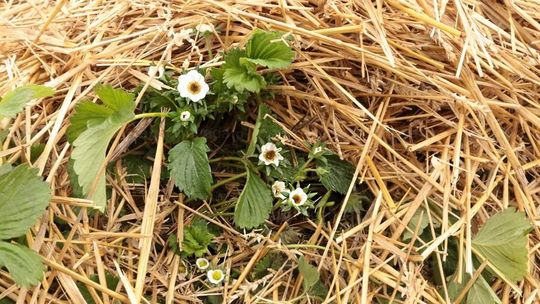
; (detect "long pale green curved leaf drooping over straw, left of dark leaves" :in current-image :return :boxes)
[71,117,130,211]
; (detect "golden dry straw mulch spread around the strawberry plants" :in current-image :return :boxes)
[0,0,540,303]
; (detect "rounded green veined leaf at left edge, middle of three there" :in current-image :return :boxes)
[0,165,51,240]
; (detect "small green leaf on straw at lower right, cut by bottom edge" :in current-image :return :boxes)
[448,273,501,304]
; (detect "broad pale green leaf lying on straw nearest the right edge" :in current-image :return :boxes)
[472,208,532,282]
